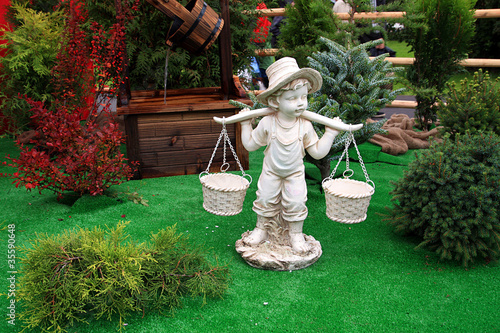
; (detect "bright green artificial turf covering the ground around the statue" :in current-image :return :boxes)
[0,139,500,333]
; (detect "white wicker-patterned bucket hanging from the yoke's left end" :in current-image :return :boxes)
[200,172,250,216]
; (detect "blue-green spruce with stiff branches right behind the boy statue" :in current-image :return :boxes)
[306,37,403,179]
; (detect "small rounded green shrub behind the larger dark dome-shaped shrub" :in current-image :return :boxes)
[437,69,500,137]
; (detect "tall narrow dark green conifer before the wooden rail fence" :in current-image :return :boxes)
[403,0,475,130]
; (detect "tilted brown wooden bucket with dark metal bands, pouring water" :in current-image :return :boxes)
[147,0,224,54]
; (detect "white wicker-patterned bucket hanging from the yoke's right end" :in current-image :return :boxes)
[323,178,375,223]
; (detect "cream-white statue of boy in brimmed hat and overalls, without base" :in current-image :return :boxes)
[240,57,339,253]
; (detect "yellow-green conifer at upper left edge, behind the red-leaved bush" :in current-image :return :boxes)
[0,5,64,132]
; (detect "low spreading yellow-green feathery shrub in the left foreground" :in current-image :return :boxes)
[19,223,228,332]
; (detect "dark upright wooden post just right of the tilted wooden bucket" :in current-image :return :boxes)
[219,0,233,100]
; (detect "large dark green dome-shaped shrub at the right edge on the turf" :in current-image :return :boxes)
[388,134,500,266]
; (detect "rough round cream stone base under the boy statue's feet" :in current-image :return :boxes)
[236,231,323,271]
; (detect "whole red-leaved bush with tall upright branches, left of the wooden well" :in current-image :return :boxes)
[0,0,135,198]
